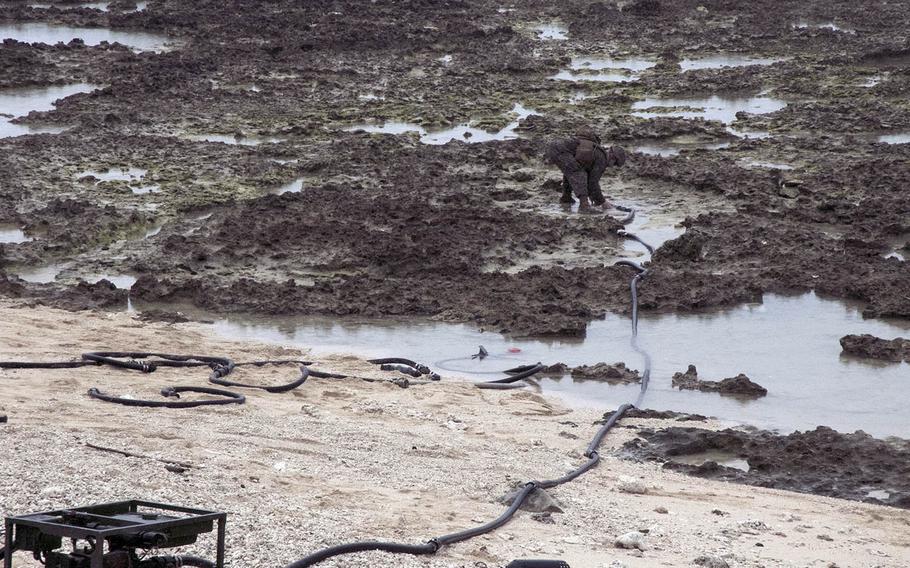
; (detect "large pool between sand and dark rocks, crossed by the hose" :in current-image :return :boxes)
[183,293,910,437]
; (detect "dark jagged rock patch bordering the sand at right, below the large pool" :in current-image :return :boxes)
[621,427,910,509]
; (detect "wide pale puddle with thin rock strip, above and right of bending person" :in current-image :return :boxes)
[632,95,787,125]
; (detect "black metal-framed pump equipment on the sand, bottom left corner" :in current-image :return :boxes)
[3,500,227,568]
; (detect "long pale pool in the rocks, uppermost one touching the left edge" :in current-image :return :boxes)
[0,22,173,52]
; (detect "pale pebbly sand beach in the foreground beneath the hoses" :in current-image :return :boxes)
[0,304,910,568]
